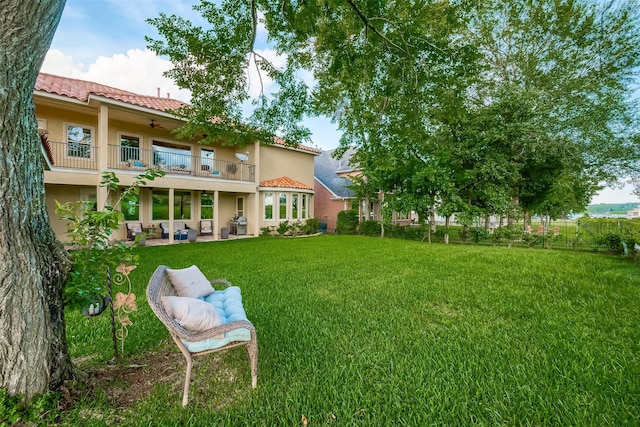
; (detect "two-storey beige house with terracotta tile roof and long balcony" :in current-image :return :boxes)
[34,73,320,241]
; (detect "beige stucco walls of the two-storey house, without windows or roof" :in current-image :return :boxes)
[34,77,317,241]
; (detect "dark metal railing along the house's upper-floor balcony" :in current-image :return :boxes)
[49,141,255,181]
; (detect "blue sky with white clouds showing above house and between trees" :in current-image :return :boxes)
[42,0,640,207]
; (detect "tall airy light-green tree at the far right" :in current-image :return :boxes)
[467,0,640,213]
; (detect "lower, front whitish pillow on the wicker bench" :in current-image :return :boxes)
[162,297,224,339]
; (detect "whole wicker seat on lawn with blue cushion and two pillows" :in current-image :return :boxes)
[147,265,258,406]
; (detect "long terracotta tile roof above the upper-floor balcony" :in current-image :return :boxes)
[36,73,185,111]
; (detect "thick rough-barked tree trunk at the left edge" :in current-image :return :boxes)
[0,0,72,400]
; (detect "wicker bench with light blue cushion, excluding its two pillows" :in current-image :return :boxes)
[147,265,258,406]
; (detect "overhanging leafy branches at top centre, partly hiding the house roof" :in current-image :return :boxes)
[148,0,468,147]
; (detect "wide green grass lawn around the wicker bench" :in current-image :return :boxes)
[56,236,640,426]
